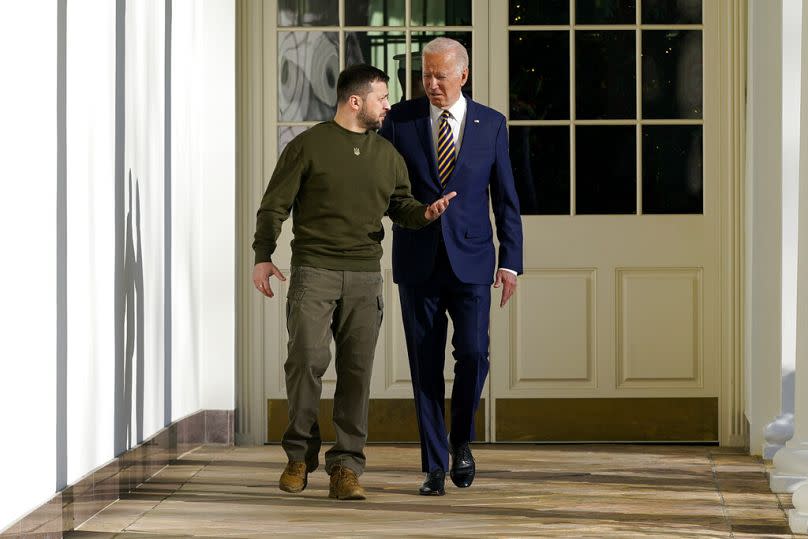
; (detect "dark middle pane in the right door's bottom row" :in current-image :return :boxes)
[575,125,637,214]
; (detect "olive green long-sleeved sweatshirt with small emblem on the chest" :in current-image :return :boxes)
[253,121,428,271]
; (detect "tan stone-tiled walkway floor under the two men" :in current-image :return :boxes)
[68,445,791,538]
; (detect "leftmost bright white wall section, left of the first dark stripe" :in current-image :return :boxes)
[0,0,57,529]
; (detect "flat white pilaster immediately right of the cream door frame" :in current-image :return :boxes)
[744,0,783,460]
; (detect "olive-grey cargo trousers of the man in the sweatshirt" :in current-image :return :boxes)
[282,266,384,475]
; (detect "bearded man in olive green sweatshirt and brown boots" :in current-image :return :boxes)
[253,65,456,500]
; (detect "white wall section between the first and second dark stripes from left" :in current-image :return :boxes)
[66,0,115,483]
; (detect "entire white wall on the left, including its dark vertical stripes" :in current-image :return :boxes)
[0,0,235,530]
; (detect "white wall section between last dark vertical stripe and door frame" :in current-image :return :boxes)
[171,0,236,418]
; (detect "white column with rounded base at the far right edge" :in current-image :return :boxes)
[769,0,808,510]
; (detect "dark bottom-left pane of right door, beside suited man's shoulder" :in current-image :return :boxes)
[509,126,570,215]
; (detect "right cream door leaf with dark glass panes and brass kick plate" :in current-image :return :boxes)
[490,0,723,441]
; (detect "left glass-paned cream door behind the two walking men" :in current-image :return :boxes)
[264,0,489,441]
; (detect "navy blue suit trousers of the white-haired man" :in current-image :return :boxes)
[398,242,491,472]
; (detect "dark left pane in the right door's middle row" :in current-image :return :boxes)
[508,30,570,120]
